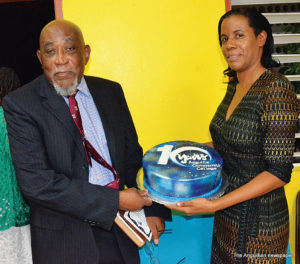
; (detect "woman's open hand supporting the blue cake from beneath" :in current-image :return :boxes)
[165,198,216,215]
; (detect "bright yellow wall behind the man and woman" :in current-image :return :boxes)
[63,0,300,262]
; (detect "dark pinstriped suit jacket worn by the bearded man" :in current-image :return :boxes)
[3,75,168,264]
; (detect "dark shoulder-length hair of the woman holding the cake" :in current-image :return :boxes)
[218,8,280,79]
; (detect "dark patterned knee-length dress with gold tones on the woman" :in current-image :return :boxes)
[210,70,299,264]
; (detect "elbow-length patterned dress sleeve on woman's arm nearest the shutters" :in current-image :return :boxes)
[261,78,299,183]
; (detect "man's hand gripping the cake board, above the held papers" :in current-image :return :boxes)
[119,188,152,211]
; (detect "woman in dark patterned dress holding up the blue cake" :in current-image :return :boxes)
[169,9,299,264]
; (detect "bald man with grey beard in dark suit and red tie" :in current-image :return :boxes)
[3,20,169,264]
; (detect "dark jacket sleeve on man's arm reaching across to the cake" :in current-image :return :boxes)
[3,94,119,230]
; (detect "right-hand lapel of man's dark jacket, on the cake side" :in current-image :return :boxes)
[84,76,118,171]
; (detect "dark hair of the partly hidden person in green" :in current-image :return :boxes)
[0,67,20,102]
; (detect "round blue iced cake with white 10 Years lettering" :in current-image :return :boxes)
[143,141,223,203]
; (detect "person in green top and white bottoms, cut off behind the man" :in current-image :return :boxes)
[0,67,32,264]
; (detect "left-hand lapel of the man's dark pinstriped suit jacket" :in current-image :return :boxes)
[40,76,86,160]
